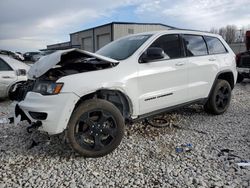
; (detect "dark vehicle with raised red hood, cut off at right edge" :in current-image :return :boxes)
[236,31,250,82]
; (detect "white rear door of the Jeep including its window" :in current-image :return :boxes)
[182,34,219,101]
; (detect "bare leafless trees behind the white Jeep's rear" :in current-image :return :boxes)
[210,25,250,44]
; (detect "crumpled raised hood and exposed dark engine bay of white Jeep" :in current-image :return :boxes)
[11,49,118,101]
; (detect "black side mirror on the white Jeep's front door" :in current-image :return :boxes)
[140,47,165,63]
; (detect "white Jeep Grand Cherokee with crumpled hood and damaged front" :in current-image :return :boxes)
[15,30,237,157]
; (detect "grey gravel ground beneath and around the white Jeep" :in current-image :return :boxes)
[0,81,250,188]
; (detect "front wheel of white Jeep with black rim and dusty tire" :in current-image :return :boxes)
[66,99,124,158]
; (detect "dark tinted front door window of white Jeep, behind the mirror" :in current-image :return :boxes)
[150,35,183,59]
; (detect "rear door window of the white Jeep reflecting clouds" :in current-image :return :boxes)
[183,35,208,57]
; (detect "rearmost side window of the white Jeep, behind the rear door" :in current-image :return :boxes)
[204,36,227,54]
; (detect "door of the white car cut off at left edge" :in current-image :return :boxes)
[0,58,17,97]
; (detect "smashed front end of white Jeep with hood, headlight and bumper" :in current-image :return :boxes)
[13,49,118,134]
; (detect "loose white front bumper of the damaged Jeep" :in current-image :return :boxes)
[15,92,79,134]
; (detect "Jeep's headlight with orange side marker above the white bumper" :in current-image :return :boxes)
[33,81,63,95]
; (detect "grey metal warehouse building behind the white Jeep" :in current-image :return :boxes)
[47,22,173,52]
